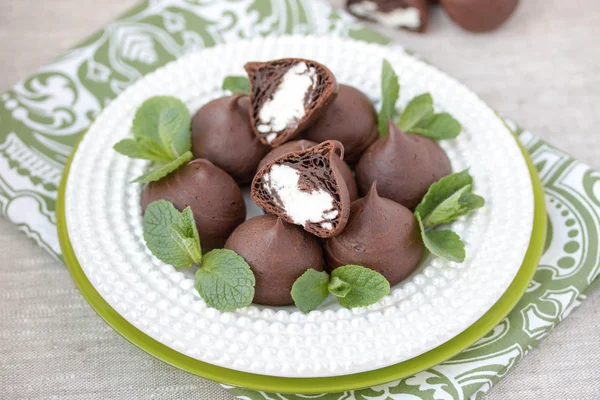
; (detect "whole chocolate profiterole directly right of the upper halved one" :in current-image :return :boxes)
[303,85,378,164]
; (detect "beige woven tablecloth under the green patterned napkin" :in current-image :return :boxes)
[0,0,600,400]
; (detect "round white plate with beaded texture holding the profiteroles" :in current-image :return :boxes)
[66,37,533,377]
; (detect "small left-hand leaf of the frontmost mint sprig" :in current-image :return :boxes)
[292,268,329,313]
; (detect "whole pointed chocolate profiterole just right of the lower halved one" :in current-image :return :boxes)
[325,183,424,285]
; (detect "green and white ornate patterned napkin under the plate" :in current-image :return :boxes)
[0,0,600,400]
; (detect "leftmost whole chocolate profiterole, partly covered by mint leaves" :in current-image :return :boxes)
[142,158,246,252]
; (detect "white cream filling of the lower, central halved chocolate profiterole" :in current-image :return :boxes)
[263,164,339,230]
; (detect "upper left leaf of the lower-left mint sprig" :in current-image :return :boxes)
[142,200,200,268]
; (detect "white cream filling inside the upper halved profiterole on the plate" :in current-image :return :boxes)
[256,62,317,143]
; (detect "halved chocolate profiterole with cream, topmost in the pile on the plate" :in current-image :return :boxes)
[244,58,338,147]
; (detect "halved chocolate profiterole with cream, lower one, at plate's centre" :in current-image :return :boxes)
[252,140,350,238]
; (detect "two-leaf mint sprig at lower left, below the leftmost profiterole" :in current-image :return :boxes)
[143,200,256,311]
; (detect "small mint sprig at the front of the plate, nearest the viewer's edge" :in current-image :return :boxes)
[292,265,390,313]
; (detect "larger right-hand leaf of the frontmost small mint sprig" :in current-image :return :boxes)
[331,265,390,308]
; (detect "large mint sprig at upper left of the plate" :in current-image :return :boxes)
[114,96,193,182]
